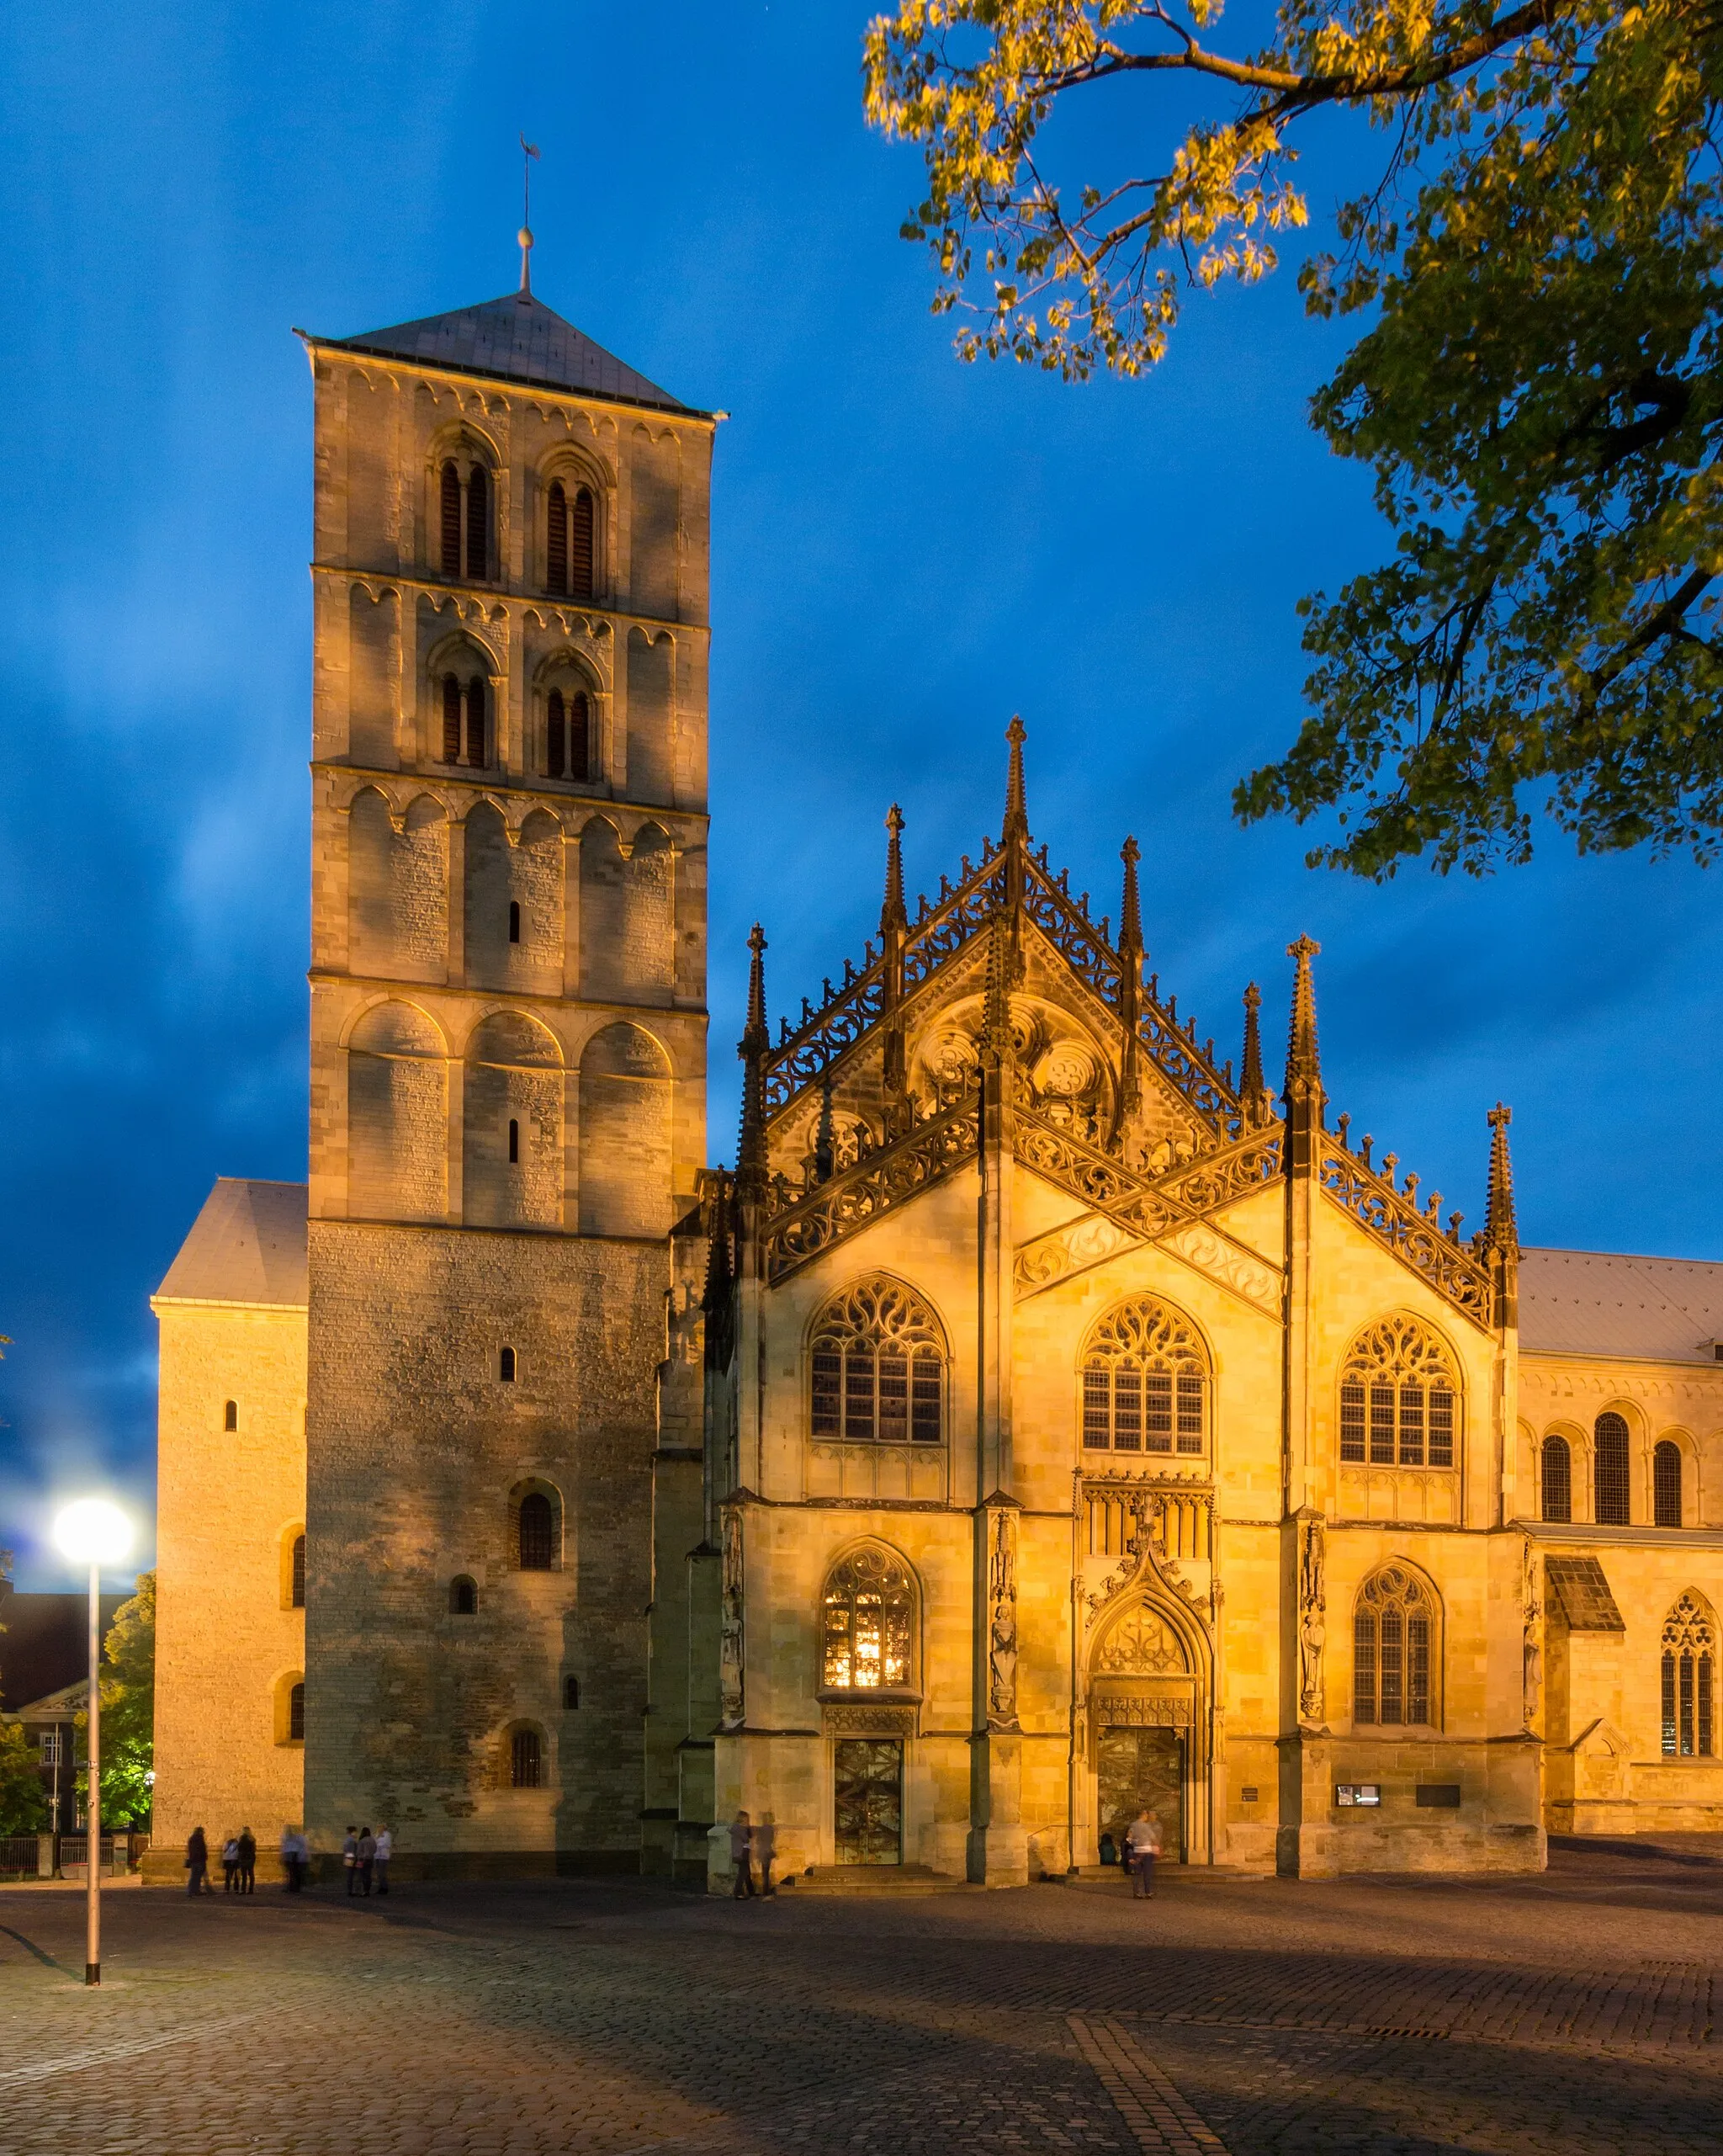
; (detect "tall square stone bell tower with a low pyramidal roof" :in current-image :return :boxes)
[304,278,713,1873]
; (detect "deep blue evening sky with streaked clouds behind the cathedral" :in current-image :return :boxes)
[0,0,1723,1587]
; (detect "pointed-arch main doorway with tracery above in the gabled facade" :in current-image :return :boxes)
[1083,1596,1212,1863]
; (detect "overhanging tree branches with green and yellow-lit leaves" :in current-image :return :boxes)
[867,0,1723,878]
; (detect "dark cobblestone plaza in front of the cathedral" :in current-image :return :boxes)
[0,1837,1723,2156]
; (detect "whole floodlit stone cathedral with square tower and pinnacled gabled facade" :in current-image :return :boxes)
[151,276,1723,1887]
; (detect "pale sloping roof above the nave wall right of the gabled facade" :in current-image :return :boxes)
[1520,1251,1723,1362]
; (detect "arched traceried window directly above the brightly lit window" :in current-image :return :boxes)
[808,1278,945,1445]
